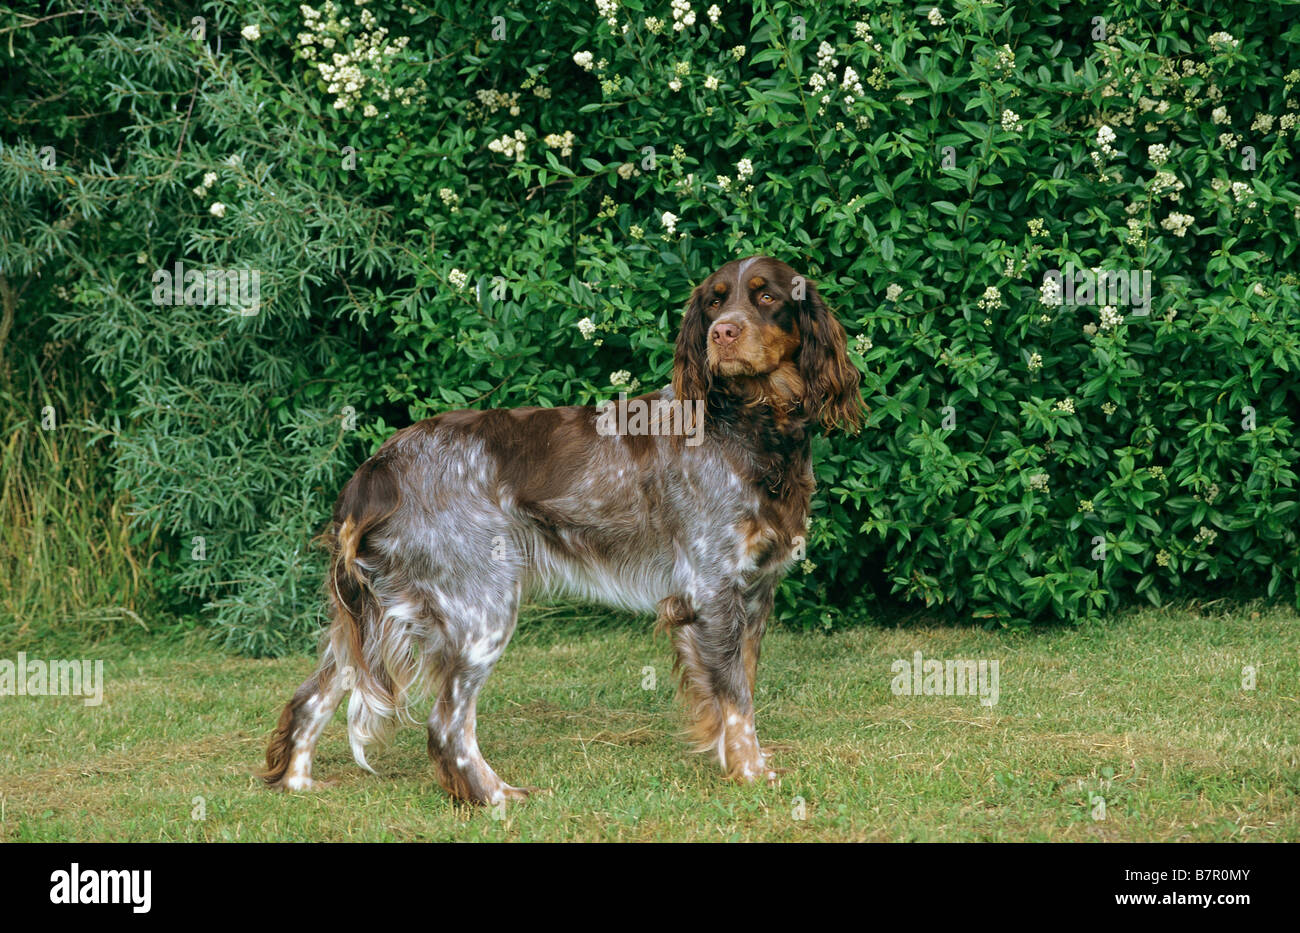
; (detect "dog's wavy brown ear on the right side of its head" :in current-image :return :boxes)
[798,282,865,434]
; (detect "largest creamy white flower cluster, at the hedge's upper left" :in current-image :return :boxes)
[298,0,428,117]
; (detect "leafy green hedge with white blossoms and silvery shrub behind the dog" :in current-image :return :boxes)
[0,0,1300,654]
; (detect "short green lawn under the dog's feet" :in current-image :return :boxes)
[0,606,1300,841]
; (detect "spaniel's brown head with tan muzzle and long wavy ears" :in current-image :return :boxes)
[672,256,863,431]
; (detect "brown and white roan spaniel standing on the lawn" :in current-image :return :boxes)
[263,256,863,803]
